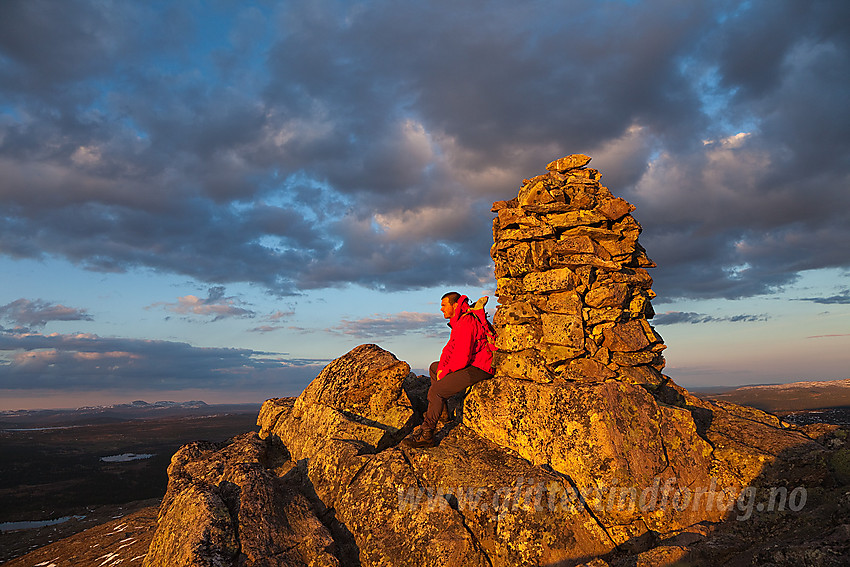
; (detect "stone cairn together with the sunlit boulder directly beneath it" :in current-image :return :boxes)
[464,155,815,545]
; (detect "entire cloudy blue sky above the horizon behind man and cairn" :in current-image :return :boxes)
[0,0,850,410]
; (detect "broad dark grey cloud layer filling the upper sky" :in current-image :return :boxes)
[0,0,850,300]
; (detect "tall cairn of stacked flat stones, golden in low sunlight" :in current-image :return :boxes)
[490,154,666,387]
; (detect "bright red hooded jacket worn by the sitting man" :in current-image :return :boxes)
[437,295,493,378]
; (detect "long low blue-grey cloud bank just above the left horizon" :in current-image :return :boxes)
[0,330,328,390]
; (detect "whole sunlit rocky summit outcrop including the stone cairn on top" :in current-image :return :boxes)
[145,156,834,567]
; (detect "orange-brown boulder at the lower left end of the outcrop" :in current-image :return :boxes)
[144,433,339,567]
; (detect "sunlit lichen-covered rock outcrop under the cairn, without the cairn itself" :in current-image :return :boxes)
[139,345,830,566]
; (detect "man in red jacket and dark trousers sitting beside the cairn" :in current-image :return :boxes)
[405,291,493,447]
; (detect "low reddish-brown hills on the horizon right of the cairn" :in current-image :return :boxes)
[695,378,850,412]
